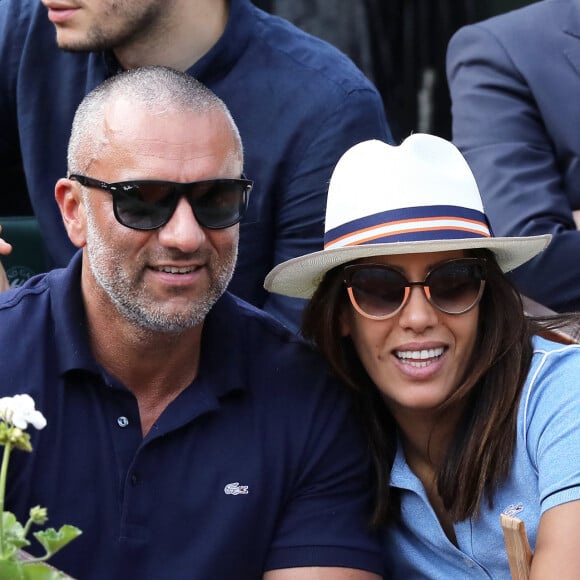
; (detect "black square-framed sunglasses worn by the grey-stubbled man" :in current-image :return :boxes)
[69,174,254,230]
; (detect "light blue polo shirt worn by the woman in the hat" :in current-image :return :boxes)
[385,337,580,580]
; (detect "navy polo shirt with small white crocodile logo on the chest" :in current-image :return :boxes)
[0,253,381,580]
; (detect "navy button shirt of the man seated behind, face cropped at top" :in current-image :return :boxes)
[0,0,391,328]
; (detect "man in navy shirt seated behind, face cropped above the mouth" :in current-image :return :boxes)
[0,0,390,328]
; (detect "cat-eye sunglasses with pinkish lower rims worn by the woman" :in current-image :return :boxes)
[343,258,486,320]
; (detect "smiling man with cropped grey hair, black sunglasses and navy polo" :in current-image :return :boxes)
[0,67,381,580]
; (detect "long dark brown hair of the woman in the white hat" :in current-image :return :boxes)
[302,250,576,526]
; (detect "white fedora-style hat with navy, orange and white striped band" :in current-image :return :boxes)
[264,133,551,298]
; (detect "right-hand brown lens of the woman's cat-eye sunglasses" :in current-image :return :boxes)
[425,260,485,314]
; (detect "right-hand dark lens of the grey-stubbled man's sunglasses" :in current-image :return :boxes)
[189,179,247,229]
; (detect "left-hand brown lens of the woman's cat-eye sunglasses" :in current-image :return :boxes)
[346,266,406,318]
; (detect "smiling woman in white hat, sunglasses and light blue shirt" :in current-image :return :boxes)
[265,134,580,580]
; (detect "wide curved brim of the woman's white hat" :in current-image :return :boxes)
[264,234,552,298]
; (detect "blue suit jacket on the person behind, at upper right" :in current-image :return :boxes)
[447,0,580,311]
